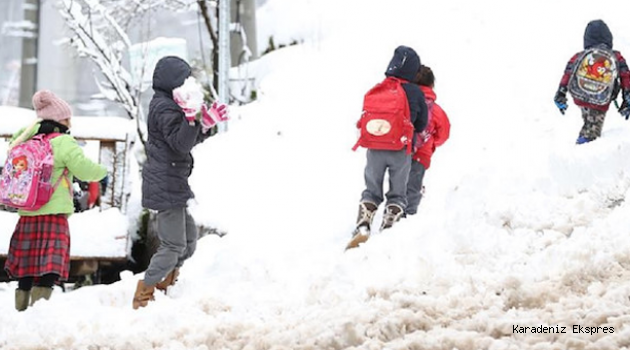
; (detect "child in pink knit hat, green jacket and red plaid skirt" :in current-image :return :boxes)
[0,90,107,311]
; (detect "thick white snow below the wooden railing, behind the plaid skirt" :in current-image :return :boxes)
[0,208,131,258]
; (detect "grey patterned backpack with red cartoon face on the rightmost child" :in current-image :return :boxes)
[568,46,619,106]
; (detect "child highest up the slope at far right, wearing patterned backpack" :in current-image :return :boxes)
[554,20,630,144]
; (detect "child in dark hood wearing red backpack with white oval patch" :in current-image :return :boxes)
[348,46,427,248]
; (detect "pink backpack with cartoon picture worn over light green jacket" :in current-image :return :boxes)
[0,133,68,211]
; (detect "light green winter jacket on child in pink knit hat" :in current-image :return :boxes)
[11,125,107,216]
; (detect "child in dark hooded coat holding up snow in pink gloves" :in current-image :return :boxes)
[133,56,227,309]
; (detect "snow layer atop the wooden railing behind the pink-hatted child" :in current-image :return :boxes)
[0,106,136,141]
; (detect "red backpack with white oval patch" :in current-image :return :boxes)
[352,77,414,153]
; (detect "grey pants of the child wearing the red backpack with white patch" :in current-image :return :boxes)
[361,149,411,209]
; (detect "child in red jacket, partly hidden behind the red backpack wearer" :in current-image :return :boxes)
[405,66,451,216]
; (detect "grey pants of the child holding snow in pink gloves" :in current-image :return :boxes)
[144,208,197,286]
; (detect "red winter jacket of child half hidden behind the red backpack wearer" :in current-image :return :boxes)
[413,86,451,169]
